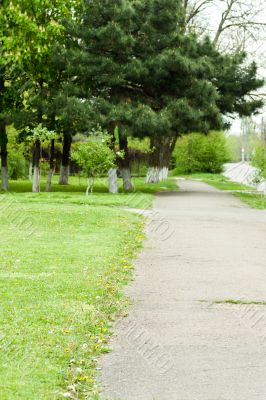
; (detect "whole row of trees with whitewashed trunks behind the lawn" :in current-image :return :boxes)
[0,0,264,192]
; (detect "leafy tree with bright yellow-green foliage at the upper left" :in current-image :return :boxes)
[1,0,79,186]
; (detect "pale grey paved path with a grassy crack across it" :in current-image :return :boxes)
[101,181,266,400]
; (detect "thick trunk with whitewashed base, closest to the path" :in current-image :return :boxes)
[146,136,177,183]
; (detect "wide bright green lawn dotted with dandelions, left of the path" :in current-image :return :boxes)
[0,179,179,400]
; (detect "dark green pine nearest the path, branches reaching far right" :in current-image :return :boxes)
[130,0,263,181]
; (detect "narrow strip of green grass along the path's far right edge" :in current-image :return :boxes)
[179,173,266,210]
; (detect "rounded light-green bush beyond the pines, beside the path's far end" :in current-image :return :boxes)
[174,132,229,175]
